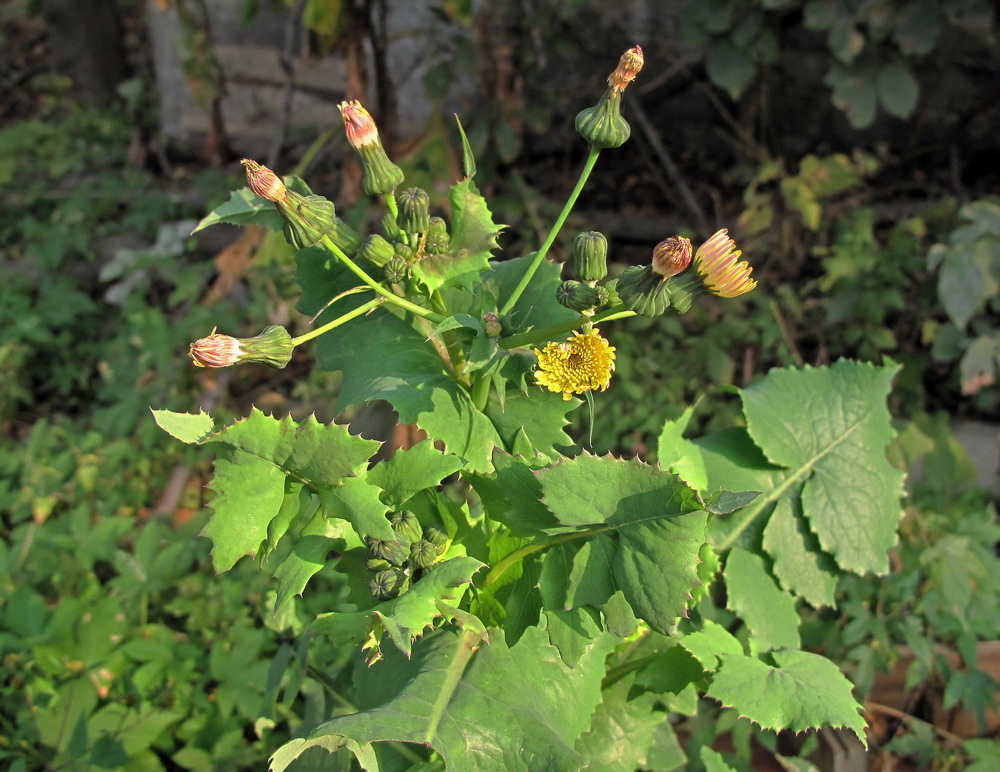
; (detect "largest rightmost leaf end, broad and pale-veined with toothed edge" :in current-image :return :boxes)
[740,360,903,574]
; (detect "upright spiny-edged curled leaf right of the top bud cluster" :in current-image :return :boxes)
[413,179,503,291]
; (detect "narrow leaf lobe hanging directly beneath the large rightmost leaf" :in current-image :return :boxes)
[763,499,837,608]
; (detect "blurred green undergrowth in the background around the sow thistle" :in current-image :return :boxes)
[0,0,1000,772]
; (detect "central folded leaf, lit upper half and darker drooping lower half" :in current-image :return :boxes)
[537,453,706,634]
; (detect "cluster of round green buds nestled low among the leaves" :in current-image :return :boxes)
[365,511,448,600]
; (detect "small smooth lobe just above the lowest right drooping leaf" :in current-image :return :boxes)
[725,547,799,653]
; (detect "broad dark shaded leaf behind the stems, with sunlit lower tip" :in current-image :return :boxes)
[316,310,501,472]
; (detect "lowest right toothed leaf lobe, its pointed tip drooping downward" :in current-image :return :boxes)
[708,650,868,747]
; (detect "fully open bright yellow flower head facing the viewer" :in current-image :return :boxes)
[535,330,615,399]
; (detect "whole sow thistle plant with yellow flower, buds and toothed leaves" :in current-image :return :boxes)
[154,47,902,770]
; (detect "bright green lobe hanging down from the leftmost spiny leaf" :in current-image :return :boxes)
[202,450,285,572]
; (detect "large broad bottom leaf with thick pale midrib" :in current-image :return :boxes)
[271,628,615,772]
